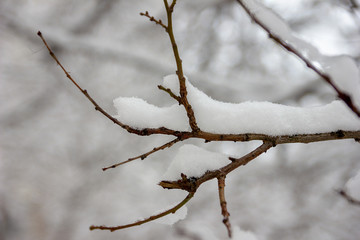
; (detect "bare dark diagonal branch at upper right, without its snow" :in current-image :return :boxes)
[237,0,360,117]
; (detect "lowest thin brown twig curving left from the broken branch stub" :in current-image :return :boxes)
[90,192,195,232]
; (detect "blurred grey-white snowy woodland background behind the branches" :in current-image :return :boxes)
[0,0,360,240]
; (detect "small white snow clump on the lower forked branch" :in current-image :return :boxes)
[163,144,230,181]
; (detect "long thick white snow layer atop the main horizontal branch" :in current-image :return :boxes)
[114,75,360,136]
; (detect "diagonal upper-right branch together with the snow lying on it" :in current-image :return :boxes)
[237,0,360,118]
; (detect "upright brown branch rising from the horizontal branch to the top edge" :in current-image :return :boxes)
[164,0,200,132]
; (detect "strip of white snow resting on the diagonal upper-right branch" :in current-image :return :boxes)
[243,0,360,108]
